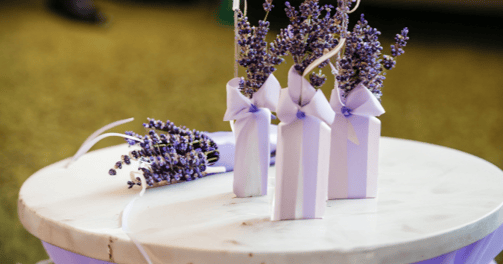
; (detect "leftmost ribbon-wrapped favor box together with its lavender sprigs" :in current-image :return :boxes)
[224,0,284,197]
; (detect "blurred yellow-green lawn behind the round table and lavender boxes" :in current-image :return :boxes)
[0,2,503,264]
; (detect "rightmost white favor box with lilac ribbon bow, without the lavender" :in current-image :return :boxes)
[328,84,384,200]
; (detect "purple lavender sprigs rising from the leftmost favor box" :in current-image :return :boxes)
[237,0,285,98]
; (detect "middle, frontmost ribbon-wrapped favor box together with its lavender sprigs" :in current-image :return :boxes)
[271,0,345,220]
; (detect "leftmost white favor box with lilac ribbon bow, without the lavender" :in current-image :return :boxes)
[224,74,281,197]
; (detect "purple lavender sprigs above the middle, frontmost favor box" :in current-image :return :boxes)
[271,0,345,88]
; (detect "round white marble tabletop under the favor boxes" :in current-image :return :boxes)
[18,138,503,264]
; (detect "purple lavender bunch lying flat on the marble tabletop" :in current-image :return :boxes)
[109,118,219,188]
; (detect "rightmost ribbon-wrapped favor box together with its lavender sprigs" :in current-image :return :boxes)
[328,9,409,199]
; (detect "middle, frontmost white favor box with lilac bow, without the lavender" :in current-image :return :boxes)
[272,67,334,220]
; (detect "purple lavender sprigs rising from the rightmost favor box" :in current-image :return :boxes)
[337,14,409,99]
